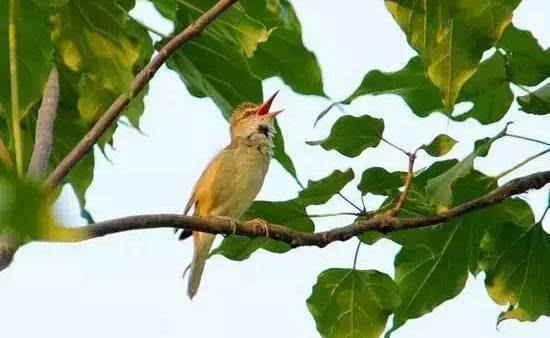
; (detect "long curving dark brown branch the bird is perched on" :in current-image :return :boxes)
[46,171,550,247]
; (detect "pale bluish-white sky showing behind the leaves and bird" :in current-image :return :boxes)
[0,0,550,338]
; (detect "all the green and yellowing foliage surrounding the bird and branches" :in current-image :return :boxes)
[0,0,550,337]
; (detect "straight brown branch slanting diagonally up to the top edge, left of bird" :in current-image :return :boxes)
[45,0,238,188]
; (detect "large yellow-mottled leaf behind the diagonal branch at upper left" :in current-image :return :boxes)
[39,0,153,214]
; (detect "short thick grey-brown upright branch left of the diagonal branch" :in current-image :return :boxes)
[27,67,59,180]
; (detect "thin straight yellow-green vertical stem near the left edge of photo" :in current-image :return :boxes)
[8,0,23,177]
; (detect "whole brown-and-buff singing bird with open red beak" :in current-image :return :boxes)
[180,93,282,298]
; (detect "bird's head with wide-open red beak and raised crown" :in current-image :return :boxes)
[231,92,282,139]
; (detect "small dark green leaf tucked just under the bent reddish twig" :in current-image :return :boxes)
[357,167,407,195]
